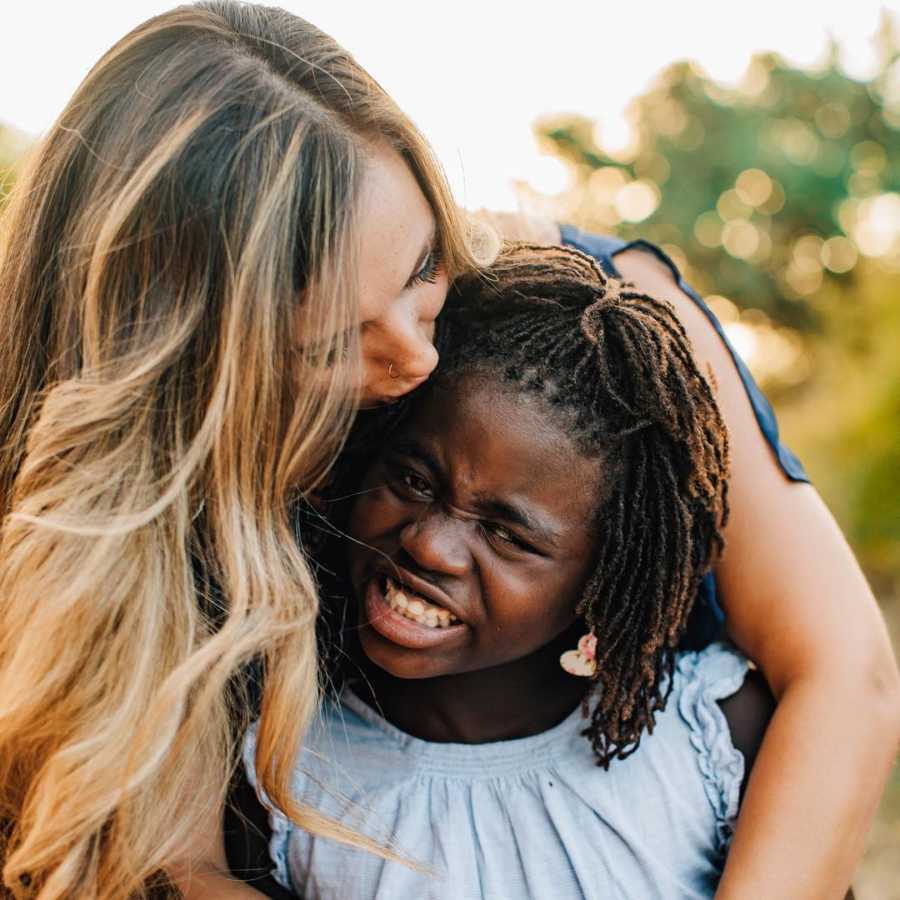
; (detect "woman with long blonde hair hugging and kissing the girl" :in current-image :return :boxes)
[0,3,898,898]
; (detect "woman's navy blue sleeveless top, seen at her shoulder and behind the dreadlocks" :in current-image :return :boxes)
[560,225,809,648]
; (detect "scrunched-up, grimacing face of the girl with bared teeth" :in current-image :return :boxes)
[349,377,602,678]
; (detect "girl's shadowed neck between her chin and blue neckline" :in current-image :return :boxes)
[354,628,587,744]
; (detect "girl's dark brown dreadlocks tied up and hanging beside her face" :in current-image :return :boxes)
[436,244,740,767]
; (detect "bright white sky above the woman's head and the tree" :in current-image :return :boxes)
[0,0,900,209]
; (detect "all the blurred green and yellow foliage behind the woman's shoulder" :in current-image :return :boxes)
[536,14,900,593]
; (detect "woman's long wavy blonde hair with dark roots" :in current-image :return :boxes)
[0,2,486,900]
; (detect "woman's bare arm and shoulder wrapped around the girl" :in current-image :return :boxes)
[615,243,900,900]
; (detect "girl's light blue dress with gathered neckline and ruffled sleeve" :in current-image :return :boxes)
[244,644,747,900]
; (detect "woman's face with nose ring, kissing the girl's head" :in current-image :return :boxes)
[359,145,447,406]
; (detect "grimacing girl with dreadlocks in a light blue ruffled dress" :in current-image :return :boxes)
[239,246,796,898]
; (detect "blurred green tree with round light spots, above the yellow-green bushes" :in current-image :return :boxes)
[539,15,900,330]
